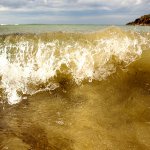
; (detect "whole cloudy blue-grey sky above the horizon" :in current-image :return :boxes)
[0,0,150,25]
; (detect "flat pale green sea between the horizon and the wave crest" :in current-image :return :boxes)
[0,24,150,34]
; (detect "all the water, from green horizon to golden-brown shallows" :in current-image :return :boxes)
[0,25,150,150]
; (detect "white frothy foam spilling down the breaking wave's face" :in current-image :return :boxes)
[0,30,145,104]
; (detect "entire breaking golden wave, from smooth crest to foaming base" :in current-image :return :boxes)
[0,27,150,104]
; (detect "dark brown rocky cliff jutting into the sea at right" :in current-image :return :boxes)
[126,14,150,26]
